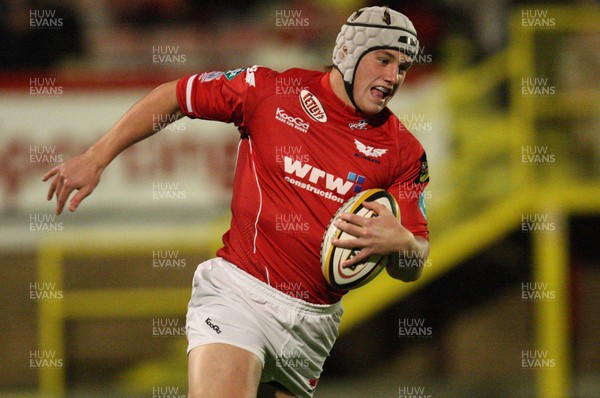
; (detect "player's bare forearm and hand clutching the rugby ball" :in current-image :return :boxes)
[332,202,429,282]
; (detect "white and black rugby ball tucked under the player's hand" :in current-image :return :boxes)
[321,188,400,290]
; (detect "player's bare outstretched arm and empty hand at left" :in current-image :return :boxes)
[42,80,182,214]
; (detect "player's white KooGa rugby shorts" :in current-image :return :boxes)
[186,258,343,397]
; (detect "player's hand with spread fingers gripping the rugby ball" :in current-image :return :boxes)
[331,202,415,268]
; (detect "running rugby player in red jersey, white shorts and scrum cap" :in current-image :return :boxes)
[43,7,429,398]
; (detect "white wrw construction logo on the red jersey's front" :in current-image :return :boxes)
[283,156,365,203]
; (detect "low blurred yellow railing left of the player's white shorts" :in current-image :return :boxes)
[38,220,226,397]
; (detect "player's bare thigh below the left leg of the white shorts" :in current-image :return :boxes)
[188,343,262,398]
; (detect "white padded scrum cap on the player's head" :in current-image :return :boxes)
[333,7,419,102]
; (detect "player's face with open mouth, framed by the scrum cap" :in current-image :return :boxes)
[353,49,412,115]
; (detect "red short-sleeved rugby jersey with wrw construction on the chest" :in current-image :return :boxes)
[177,66,428,304]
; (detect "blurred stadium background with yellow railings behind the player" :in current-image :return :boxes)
[0,0,600,398]
